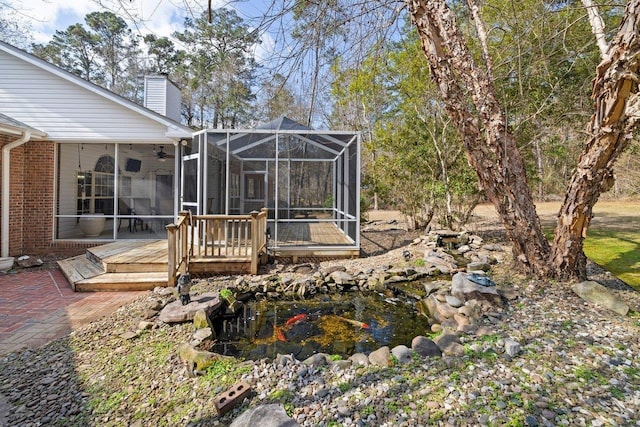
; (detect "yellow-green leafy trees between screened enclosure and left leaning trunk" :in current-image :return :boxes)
[333,31,477,228]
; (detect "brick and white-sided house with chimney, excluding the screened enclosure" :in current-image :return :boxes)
[0,42,192,256]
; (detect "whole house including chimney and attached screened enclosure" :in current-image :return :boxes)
[0,42,360,278]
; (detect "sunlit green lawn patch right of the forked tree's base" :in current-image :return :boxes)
[584,229,640,291]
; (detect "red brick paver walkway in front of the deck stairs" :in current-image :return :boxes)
[0,270,145,356]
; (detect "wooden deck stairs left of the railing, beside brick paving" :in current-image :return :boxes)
[58,240,168,291]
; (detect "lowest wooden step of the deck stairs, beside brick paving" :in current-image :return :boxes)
[75,271,168,292]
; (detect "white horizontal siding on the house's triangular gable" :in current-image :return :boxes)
[0,50,185,143]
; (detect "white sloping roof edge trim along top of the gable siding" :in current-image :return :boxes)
[0,40,193,138]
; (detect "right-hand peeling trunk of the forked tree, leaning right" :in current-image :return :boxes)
[552,0,640,278]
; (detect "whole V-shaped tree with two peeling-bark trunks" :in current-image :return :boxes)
[406,0,640,278]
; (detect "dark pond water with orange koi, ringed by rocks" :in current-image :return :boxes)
[211,292,430,360]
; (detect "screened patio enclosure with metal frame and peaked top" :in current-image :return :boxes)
[188,117,360,256]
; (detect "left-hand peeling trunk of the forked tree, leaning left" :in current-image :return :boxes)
[407,0,550,276]
